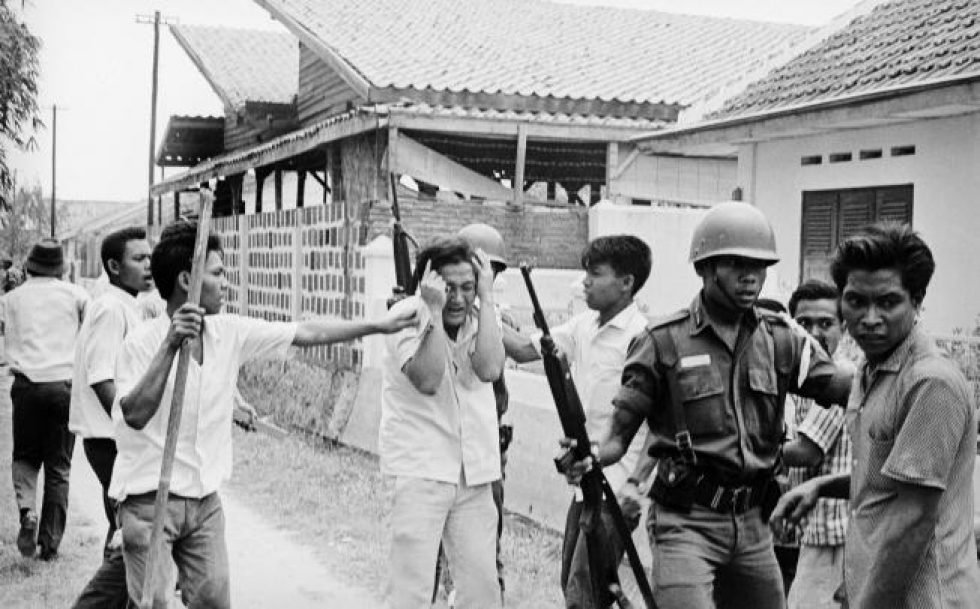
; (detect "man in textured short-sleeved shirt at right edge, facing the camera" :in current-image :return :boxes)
[771,223,980,609]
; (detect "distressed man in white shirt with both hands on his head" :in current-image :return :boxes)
[380,237,504,609]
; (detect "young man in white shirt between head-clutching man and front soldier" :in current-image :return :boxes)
[505,235,653,608]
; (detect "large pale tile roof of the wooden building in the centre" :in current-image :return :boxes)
[256,0,810,110]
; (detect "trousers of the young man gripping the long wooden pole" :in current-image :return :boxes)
[119,492,231,609]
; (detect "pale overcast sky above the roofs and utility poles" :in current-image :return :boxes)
[13,0,856,200]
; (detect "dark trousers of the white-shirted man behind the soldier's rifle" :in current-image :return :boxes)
[560,499,637,609]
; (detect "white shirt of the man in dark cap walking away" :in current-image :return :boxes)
[0,277,89,383]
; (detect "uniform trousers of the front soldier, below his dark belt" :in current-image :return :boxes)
[647,501,786,609]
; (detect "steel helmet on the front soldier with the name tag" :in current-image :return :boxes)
[690,201,779,264]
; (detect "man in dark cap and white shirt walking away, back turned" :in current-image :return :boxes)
[2,239,88,560]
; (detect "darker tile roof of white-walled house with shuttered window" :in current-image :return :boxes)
[708,0,980,119]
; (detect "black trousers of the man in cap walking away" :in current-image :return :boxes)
[10,373,75,554]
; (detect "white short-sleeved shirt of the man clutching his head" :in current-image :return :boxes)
[379,297,500,486]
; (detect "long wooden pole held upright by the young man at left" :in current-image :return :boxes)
[140,189,214,609]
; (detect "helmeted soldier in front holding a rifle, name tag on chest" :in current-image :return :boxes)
[566,202,850,609]
